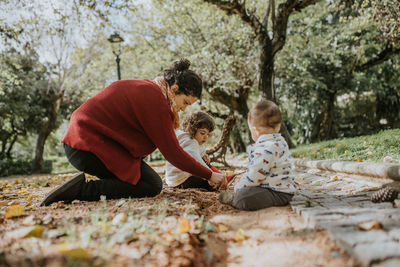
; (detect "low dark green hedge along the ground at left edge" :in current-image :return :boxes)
[0,159,53,177]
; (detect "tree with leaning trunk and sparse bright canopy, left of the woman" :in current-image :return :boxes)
[1,0,117,172]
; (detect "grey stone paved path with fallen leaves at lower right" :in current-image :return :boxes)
[291,168,400,267]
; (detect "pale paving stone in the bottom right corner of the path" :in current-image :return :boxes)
[353,241,400,266]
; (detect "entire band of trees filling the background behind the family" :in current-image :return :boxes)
[0,0,400,176]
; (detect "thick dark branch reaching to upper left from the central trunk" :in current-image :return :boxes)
[204,0,267,35]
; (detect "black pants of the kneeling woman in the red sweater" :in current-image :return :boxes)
[64,144,162,201]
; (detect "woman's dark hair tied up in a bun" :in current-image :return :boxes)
[164,58,203,99]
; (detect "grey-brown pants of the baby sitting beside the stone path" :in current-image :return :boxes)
[232,186,293,213]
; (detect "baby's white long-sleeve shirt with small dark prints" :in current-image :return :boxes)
[235,133,297,193]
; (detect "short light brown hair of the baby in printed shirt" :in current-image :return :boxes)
[248,100,282,129]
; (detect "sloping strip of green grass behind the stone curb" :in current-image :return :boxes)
[291,129,400,163]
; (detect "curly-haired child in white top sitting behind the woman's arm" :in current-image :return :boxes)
[165,111,215,191]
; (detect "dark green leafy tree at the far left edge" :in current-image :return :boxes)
[0,49,47,159]
